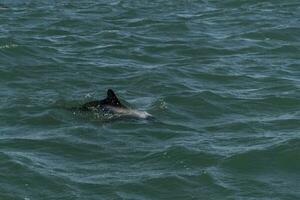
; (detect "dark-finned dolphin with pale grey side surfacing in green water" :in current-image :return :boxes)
[79,89,152,119]
